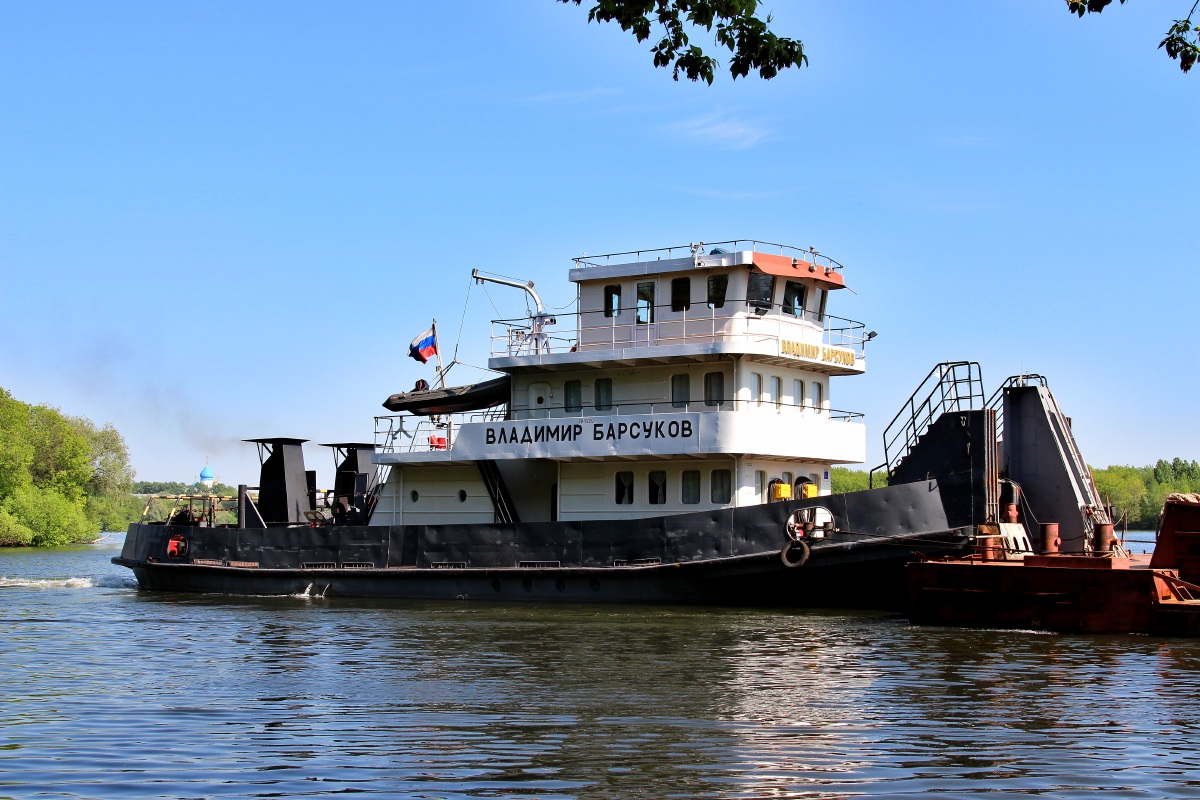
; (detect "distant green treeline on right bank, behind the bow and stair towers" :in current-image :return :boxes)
[830,458,1200,530]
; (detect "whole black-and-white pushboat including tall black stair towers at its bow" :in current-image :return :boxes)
[113,240,1110,607]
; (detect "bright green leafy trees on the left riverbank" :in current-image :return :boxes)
[0,389,140,546]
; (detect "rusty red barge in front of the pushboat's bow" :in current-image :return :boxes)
[908,495,1200,636]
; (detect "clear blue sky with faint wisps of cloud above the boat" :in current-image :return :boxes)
[0,0,1200,483]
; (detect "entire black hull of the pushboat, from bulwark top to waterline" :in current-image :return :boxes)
[113,482,971,608]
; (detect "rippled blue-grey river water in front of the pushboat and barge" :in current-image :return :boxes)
[0,545,1200,798]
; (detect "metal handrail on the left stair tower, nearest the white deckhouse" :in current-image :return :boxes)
[883,361,984,479]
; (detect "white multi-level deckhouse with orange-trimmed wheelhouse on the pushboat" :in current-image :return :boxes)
[371,241,869,525]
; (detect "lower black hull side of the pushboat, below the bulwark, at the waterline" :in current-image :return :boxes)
[113,530,968,608]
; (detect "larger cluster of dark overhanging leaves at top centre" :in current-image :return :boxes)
[558,0,809,84]
